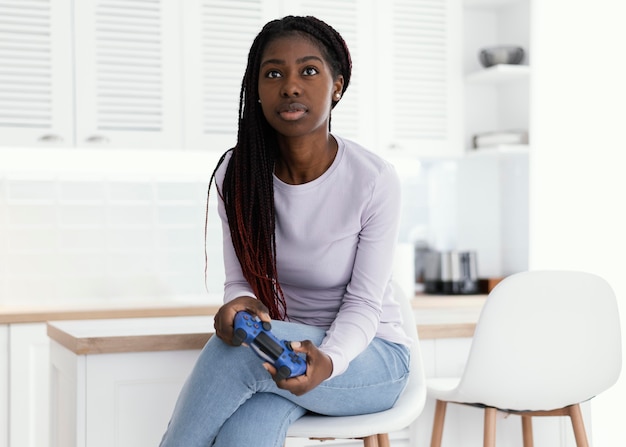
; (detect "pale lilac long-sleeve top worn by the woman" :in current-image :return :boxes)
[216,136,411,377]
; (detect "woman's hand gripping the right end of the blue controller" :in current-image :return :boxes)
[263,340,333,396]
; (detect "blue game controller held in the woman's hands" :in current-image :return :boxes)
[233,311,306,380]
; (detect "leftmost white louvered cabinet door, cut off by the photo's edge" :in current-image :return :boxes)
[0,0,73,147]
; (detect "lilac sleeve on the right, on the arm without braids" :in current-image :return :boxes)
[320,164,401,378]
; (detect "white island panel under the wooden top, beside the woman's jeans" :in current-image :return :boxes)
[84,350,199,447]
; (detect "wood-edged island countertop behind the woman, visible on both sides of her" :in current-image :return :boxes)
[48,295,486,355]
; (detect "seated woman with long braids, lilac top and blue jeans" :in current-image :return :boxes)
[162,16,410,447]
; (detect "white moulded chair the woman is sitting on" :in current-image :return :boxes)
[287,284,426,447]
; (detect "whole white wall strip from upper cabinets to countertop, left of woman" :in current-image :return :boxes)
[0,148,223,305]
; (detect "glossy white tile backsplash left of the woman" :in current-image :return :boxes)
[0,174,216,304]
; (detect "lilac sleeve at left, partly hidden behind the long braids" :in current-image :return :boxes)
[215,154,256,303]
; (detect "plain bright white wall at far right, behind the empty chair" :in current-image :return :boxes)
[529,0,626,446]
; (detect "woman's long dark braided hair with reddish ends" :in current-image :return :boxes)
[209,16,352,319]
